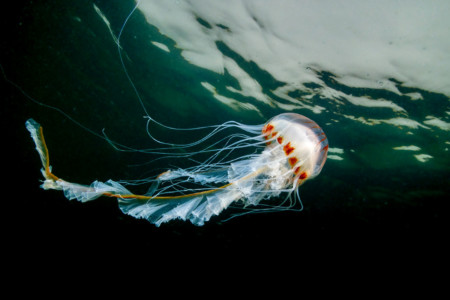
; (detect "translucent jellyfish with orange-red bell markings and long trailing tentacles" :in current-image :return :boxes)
[26,113,328,226]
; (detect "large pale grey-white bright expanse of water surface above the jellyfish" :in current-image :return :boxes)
[139,0,450,104]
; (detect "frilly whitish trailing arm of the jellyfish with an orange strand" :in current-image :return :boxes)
[26,119,264,225]
